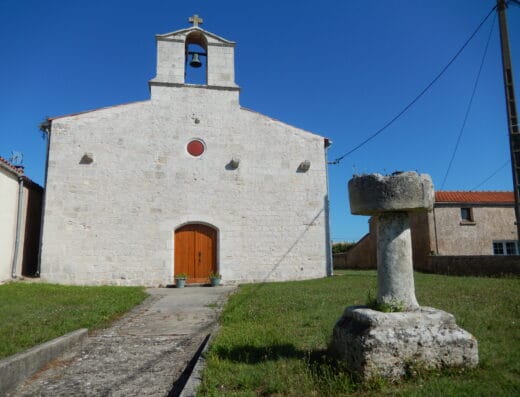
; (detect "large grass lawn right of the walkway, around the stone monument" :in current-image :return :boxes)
[201,271,520,396]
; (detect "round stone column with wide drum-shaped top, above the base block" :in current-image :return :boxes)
[348,172,434,310]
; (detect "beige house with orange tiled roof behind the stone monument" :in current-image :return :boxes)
[335,191,520,269]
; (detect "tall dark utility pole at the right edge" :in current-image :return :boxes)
[497,0,520,243]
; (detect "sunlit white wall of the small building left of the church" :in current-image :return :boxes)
[0,167,18,282]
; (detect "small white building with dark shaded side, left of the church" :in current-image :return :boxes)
[0,157,43,283]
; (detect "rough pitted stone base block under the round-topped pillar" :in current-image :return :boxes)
[330,306,478,380]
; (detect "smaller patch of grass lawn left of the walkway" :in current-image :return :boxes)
[0,283,147,358]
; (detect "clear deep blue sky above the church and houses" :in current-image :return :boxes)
[0,0,520,241]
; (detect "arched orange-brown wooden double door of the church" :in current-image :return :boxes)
[174,223,217,283]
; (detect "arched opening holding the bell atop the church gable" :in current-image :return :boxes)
[184,31,208,85]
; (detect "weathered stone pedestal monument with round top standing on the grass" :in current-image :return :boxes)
[330,172,478,380]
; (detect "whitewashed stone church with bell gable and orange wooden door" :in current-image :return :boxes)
[40,15,332,286]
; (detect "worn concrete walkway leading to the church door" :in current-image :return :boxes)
[9,286,235,396]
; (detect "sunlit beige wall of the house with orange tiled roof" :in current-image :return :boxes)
[435,205,516,255]
